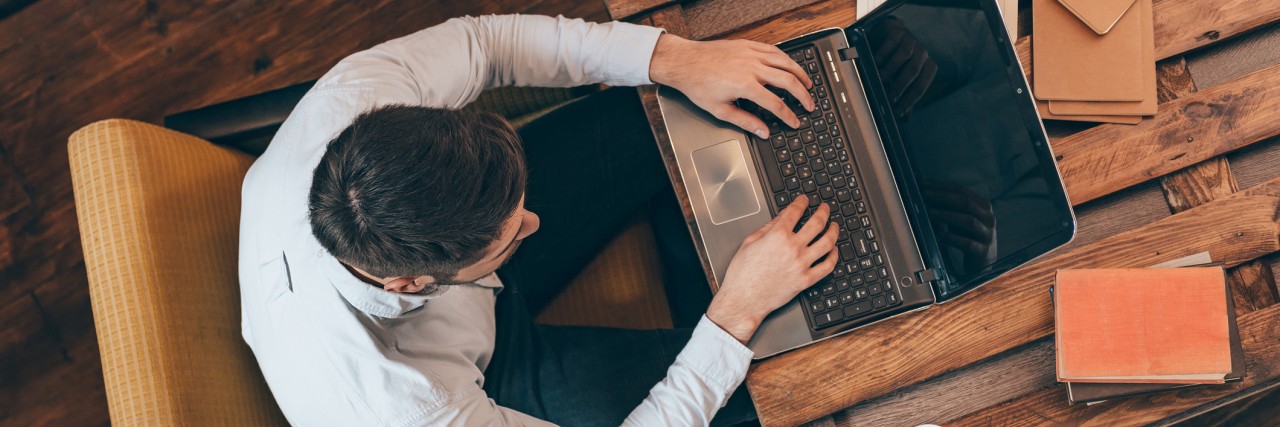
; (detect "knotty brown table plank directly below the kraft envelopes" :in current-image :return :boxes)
[1052,65,1280,205]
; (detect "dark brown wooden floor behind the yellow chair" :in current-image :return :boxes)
[0,0,608,426]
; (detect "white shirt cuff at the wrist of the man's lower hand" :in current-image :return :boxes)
[676,316,755,392]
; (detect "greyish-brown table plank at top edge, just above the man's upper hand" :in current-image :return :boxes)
[685,0,824,40]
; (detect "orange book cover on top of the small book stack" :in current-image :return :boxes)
[1053,267,1231,384]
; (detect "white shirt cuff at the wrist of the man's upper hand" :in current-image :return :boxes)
[605,22,663,86]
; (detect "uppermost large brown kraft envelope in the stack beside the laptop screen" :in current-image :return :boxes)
[1032,0,1152,101]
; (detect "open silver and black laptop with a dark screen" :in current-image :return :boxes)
[658,0,1075,358]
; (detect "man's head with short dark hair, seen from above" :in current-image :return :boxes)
[308,106,539,293]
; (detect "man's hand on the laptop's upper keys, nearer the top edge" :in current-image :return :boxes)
[649,35,813,138]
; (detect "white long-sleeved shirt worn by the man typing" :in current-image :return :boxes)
[239,17,751,426]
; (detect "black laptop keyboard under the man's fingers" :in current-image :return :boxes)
[739,46,902,330]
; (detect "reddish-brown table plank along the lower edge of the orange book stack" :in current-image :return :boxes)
[945,301,1280,427]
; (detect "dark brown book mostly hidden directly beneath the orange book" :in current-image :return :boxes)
[1066,277,1244,405]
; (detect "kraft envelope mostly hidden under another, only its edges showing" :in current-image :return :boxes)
[1048,0,1156,115]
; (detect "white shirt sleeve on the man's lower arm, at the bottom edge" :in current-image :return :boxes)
[622,316,753,426]
